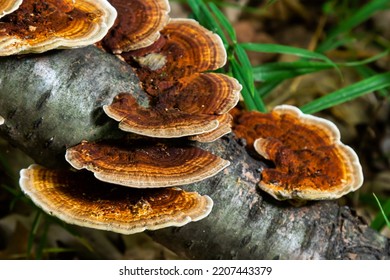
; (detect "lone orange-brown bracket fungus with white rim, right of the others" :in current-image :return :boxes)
[235,105,363,201]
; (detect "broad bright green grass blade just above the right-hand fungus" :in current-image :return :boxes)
[301,72,390,114]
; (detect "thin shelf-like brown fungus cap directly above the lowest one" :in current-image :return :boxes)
[65,139,229,188]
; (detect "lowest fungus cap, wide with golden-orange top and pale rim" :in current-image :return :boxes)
[19,165,213,234]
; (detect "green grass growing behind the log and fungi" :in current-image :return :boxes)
[187,0,390,230]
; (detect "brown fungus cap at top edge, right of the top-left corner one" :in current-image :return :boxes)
[103,0,170,54]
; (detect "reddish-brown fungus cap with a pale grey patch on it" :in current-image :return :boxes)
[122,19,226,94]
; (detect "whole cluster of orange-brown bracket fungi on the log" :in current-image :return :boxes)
[0,0,362,234]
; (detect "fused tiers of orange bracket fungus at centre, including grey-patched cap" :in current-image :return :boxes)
[104,19,241,142]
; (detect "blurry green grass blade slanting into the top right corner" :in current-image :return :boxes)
[317,0,390,53]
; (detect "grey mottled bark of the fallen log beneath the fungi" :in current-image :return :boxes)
[0,47,390,259]
